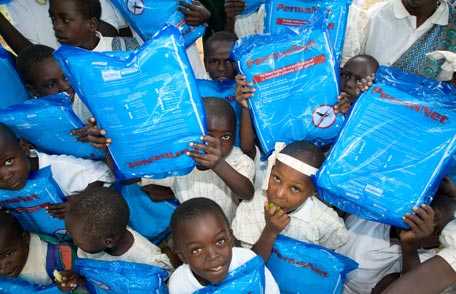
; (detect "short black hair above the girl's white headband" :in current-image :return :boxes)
[280,141,325,168]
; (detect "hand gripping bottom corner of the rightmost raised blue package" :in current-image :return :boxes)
[399,205,434,247]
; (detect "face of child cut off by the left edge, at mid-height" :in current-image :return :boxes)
[0,139,31,190]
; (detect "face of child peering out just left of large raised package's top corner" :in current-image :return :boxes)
[28,58,74,99]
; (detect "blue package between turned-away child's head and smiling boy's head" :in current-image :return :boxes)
[121,184,177,244]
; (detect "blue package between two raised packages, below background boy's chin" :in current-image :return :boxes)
[196,80,242,146]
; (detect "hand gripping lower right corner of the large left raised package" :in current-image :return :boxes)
[187,136,223,169]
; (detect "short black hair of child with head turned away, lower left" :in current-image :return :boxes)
[67,185,130,237]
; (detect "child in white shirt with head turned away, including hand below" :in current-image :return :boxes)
[61,186,172,290]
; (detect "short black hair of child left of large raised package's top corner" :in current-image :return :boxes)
[16,45,54,84]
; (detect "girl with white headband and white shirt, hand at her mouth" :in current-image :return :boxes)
[232,141,348,261]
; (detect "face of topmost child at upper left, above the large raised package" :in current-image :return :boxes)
[49,0,97,48]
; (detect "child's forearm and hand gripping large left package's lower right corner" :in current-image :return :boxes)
[188,136,255,200]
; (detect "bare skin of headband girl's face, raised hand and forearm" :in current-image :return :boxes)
[252,162,315,262]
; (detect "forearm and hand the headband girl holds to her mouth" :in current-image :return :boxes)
[252,203,290,262]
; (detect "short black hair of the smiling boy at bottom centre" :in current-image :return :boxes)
[171,197,230,241]
